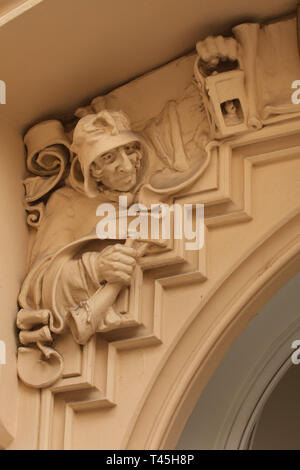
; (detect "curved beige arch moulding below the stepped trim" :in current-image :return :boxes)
[124,211,300,449]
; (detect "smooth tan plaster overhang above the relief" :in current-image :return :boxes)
[0,0,298,131]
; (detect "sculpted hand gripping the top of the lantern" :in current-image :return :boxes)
[196,36,238,72]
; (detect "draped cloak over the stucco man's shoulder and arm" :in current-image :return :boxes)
[19,186,128,333]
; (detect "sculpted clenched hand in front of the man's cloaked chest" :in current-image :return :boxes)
[96,243,138,285]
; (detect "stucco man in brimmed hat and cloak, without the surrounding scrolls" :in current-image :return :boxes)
[17,110,147,344]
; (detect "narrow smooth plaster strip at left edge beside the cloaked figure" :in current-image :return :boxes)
[0,118,28,447]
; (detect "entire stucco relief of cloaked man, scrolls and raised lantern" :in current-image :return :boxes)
[17,15,300,388]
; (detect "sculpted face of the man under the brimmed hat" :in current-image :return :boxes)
[91,142,142,191]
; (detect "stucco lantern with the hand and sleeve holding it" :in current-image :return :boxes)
[194,18,299,140]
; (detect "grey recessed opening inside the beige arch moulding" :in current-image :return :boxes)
[177,274,300,449]
